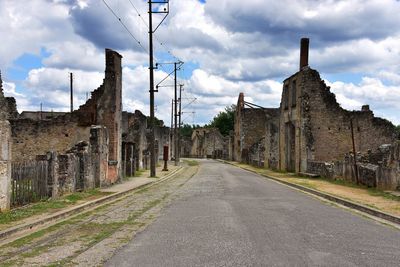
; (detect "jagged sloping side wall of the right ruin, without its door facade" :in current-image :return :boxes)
[301,69,396,161]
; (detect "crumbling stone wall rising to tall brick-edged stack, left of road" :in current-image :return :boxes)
[10,49,122,184]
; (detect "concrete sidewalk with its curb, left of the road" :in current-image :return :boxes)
[0,162,182,245]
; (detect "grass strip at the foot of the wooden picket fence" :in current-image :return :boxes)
[0,189,110,225]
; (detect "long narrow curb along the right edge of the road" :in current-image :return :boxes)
[219,160,400,225]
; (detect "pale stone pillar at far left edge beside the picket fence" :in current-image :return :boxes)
[0,121,11,212]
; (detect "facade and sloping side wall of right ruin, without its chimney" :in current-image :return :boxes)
[279,67,396,172]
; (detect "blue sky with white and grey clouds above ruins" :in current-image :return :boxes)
[0,0,400,125]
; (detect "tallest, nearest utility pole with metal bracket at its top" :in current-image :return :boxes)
[148,0,169,177]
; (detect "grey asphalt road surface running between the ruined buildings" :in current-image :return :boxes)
[106,161,400,266]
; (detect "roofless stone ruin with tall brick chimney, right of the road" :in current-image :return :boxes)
[232,39,400,192]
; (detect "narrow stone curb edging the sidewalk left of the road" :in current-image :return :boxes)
[0,167,183,242]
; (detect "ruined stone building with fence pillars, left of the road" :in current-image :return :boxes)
[0,49,170,208]
